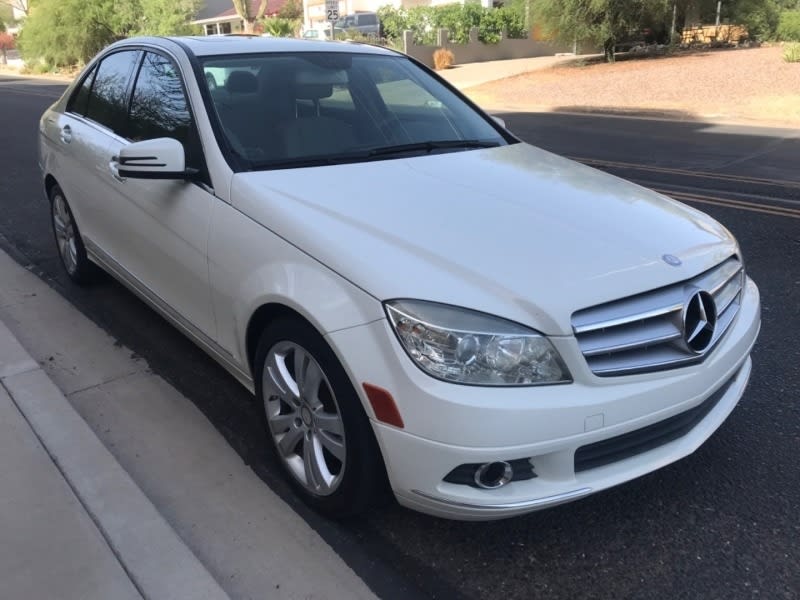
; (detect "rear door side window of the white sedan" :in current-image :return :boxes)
[86,50,139,135]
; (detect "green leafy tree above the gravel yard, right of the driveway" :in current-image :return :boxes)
[532,0,672,62]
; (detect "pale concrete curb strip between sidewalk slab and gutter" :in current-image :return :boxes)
[0,322,229,600]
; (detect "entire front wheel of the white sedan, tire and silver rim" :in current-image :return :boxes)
[255,318,385,518]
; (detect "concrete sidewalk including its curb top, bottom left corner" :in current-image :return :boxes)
[0,292,228,600]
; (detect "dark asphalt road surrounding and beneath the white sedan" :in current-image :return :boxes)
[0,77,800,599]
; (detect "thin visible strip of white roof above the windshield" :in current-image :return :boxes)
[114,35,398,56]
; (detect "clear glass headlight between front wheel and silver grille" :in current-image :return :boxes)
[385,300,572,386]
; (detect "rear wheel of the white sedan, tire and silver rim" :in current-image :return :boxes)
[49,185,99,285]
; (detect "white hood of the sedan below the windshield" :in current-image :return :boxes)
[231,143,736,335]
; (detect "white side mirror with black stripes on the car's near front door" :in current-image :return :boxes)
[112,138,197,179]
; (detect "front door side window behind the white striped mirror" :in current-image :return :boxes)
[128,52,191,145]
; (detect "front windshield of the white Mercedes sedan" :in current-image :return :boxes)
[201,52,508,169]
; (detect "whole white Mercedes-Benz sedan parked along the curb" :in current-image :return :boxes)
[39,37,760,519]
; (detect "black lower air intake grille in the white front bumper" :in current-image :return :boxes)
[575,375,736,473]
